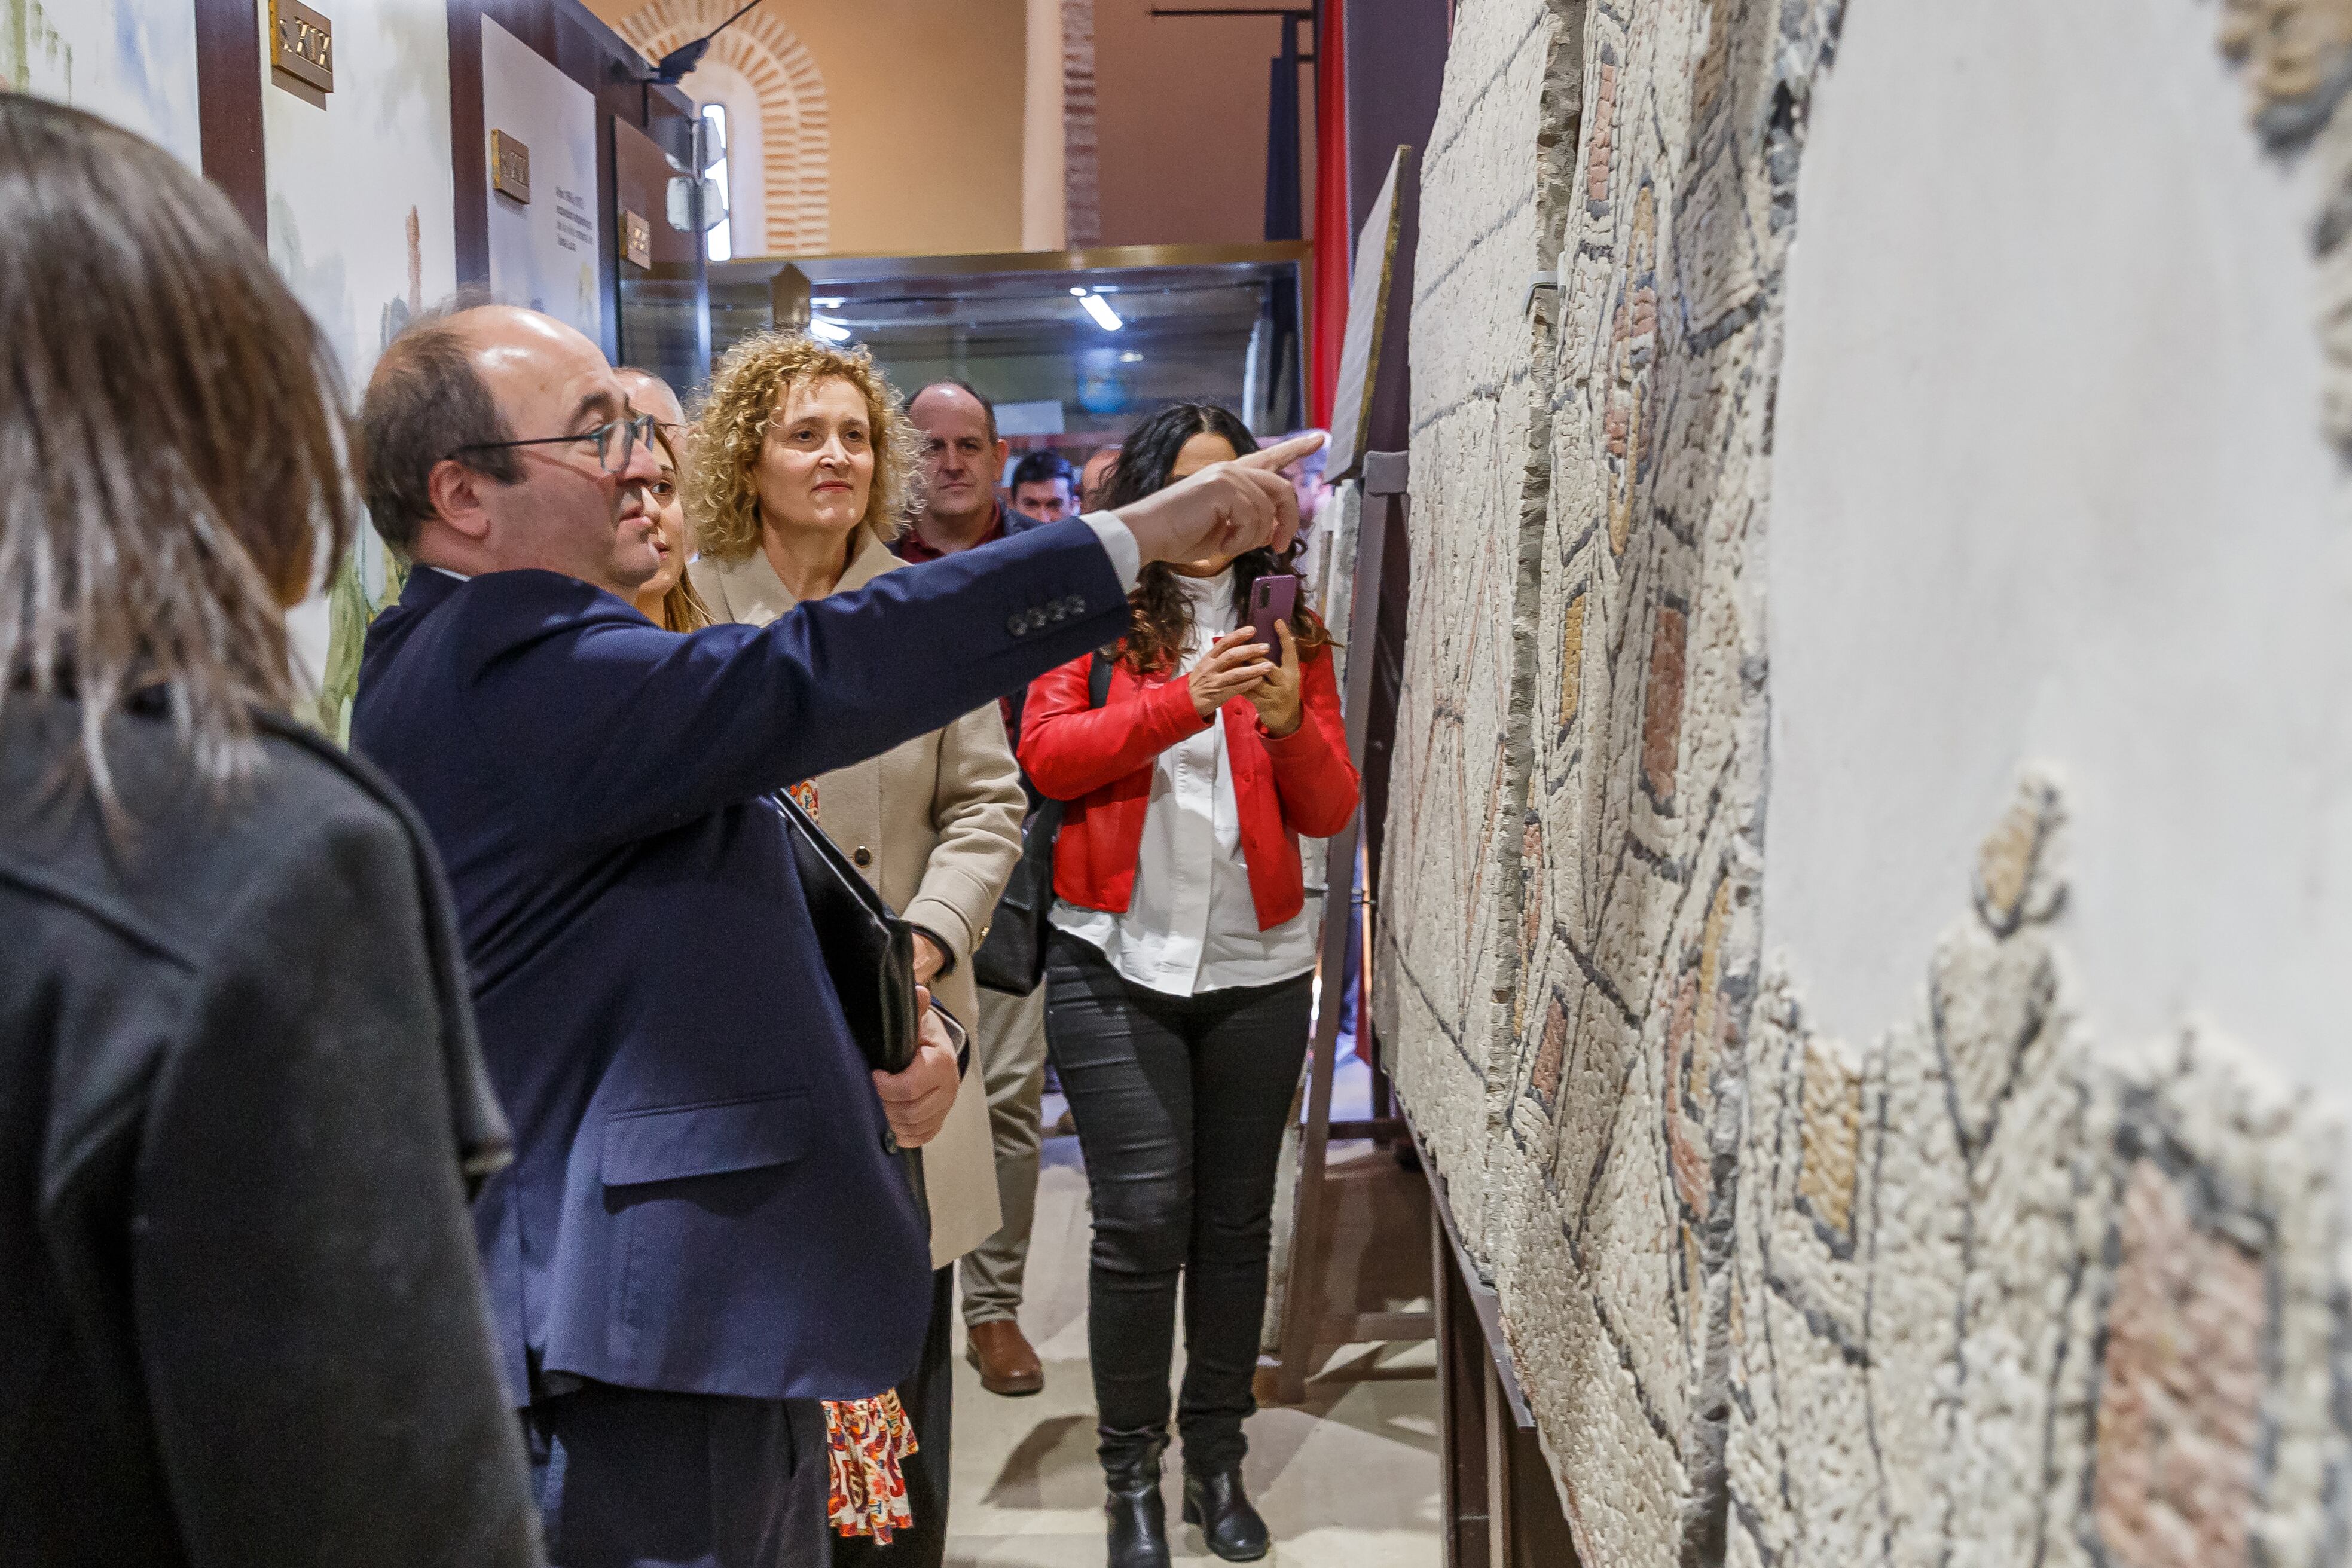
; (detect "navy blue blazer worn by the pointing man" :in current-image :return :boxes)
[350,519,1126,1404]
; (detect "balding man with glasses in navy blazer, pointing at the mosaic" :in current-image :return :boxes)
[353,308,1326,1568]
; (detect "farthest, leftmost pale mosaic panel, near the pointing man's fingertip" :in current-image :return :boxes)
[1378,0,1583,1248]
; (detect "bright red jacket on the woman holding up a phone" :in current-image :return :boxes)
[1021,651,1357,931]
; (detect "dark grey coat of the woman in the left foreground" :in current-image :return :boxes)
[0,693,541,1568]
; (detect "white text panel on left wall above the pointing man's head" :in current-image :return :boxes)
[482,17,604,343]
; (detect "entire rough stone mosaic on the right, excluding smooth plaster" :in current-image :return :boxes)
[1376,0,2352,1568]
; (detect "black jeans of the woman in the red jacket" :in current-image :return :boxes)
[1047,931,1312,1474]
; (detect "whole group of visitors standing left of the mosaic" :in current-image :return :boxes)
[0,94,1357,1568]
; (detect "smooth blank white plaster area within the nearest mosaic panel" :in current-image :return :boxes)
[1764,0,2352,1098]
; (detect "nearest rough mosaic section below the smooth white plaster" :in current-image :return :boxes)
[1727,776,2352,1568]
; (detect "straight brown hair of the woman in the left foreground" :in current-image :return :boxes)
[0,94,355,811]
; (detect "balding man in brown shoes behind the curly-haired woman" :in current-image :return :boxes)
[894,381,1049,1396]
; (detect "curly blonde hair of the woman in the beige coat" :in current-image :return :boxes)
[687,331,922,562]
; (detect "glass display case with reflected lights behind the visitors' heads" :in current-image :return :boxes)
[710,244,1308,451]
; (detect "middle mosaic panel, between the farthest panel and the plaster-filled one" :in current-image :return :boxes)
[1486,0,1837,1563]
